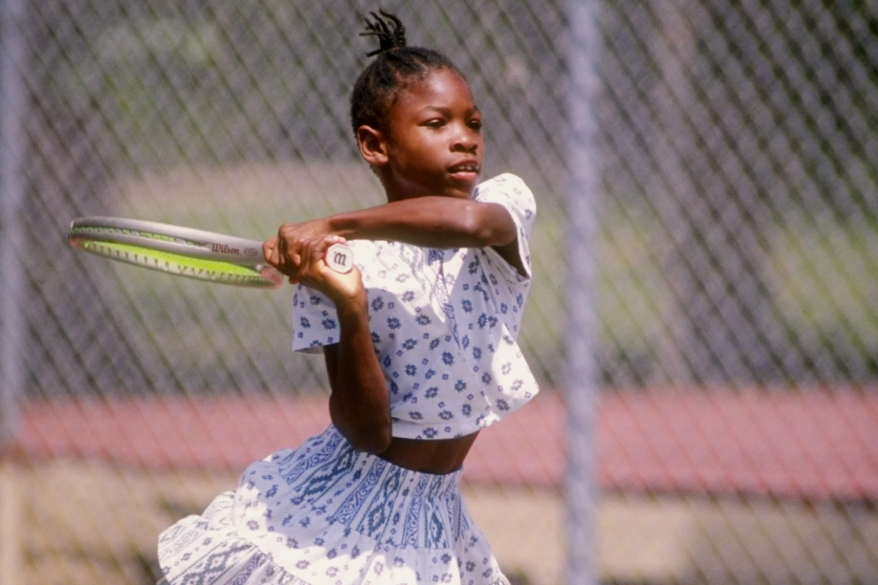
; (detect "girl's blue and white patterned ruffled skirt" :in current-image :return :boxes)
[158,426,508,585]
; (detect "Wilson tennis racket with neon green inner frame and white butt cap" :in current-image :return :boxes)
[67,216,354,288]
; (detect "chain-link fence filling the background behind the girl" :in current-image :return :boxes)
[0,0,878,585]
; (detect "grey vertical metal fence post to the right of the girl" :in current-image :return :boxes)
[565,0,599,585]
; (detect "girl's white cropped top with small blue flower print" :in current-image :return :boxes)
[293,174,539,439]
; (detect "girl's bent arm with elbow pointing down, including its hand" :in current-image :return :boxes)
[288,235,391,453]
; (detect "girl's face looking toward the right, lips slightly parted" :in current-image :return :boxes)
[379,69,484,201]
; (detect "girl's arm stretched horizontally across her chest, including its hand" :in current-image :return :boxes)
[266,196,526,275]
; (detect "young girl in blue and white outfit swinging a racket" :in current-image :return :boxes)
[159,13,537,585]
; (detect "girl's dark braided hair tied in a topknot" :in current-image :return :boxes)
[351,10,466,134]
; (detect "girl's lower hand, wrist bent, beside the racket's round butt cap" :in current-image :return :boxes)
[290,234,366,309]
